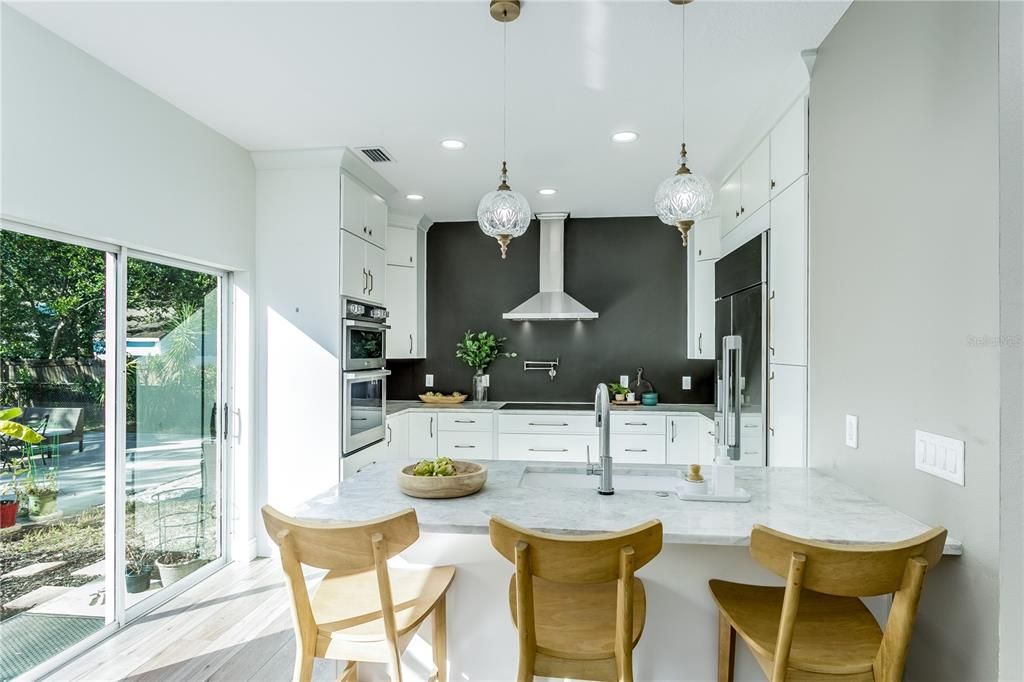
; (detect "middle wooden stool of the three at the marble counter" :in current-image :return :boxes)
[490,518,662,682]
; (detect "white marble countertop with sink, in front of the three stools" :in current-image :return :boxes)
[293,460,963,554]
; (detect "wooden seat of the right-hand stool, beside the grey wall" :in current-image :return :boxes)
[710,581,882,679]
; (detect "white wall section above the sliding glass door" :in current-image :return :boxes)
[0,5,255,269]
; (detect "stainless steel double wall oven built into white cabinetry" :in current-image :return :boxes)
[341,298,391,450]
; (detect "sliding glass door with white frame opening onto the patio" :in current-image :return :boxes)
[0,224,227,679]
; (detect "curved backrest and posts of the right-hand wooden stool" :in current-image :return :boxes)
[751,525,946,682]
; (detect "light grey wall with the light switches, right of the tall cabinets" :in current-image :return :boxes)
[809,0,999,681]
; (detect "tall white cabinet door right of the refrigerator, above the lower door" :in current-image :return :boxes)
[768,177,807,365]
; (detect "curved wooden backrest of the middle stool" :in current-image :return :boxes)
[490,517,662,584]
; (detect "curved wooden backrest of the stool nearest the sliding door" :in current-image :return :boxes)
[262,505,420,570]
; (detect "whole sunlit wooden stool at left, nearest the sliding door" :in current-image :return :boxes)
[263,506,455,682]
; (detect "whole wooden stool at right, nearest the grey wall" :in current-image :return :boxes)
[709,525,946,682]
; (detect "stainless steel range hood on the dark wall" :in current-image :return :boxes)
[502,213,598,322]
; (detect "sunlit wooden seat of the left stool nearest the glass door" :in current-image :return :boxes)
[310,566,455,642]
